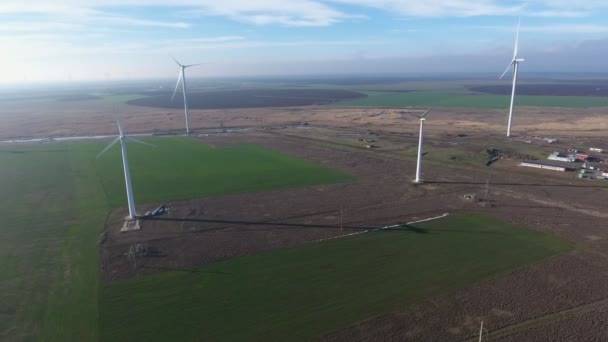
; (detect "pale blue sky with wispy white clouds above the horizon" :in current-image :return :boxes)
[0,0,608,83]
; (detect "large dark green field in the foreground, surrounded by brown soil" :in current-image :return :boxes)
[100,215,573,341]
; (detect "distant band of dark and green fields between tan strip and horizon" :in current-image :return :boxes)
[115,80,608,109]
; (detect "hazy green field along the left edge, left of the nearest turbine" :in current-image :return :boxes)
[0,144,109,341]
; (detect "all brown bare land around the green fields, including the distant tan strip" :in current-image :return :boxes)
[0,97,608,341]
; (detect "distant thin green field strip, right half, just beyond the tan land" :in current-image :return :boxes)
[329,91,608,108]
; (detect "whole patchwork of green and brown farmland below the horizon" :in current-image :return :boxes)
[0,76,608,342]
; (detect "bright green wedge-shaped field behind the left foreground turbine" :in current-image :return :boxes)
[97,137,354,206]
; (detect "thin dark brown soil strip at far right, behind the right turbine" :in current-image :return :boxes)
[469,83,608,97]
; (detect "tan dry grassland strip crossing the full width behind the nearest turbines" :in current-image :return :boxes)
[0,96,608,139]
